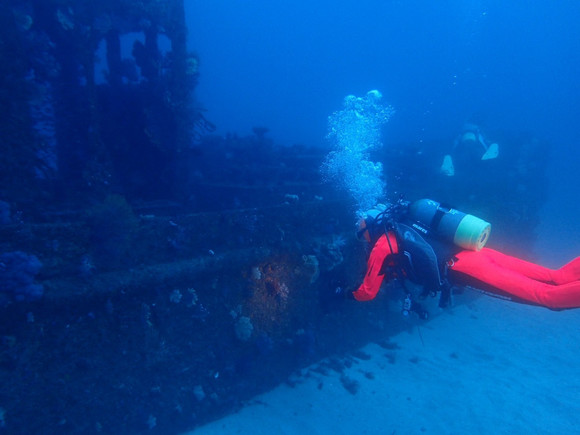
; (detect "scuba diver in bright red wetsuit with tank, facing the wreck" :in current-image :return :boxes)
[340,199,580,318]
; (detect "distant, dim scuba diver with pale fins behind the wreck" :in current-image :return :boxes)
[439,124,499,177]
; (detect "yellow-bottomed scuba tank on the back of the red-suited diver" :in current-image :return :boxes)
[408,199,491,251]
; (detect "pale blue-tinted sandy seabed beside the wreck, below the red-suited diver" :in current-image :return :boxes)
[191,296,580,435]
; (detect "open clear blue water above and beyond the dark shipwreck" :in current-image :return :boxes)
[186,0,580,265]
